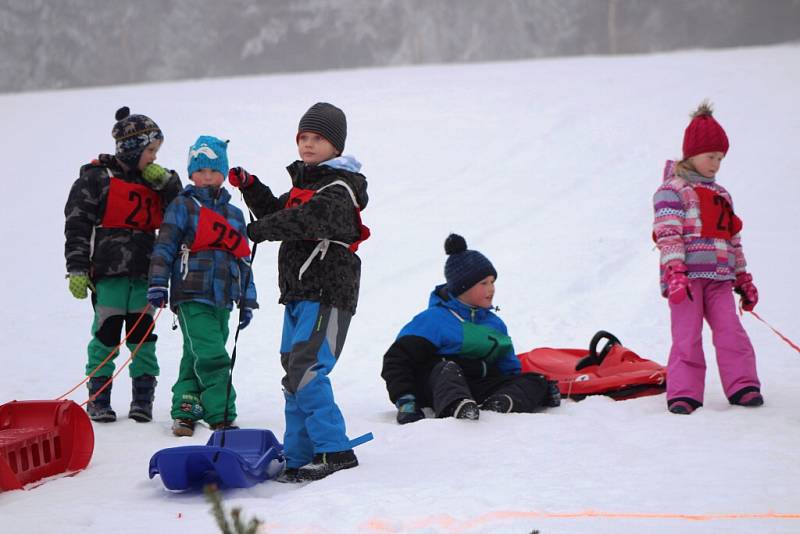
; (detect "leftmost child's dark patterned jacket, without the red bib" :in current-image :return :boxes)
[64,154,181,280]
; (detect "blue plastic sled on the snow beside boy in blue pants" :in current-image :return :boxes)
[150,429,285,491]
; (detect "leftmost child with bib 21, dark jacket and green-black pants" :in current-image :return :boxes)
[64,107,181,422]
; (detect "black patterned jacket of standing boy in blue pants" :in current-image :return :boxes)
[243,156,368,313]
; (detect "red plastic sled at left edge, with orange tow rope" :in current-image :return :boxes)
[0,400,94,491]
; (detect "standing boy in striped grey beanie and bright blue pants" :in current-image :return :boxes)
[229,103,369,481]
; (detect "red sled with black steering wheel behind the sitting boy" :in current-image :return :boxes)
[517,330,667,400]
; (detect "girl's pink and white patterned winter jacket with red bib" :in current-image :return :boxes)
[653,161,747,296]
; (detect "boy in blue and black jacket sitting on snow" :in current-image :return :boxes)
[381,234,560,425]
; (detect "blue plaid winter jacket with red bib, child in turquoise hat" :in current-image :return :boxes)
[149,185,258,310]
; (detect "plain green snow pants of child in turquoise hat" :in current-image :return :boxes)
[172,302,236,425]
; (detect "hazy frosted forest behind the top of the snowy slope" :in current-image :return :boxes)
[0,0,800,92]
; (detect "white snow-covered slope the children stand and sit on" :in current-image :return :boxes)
[0,46,800,534]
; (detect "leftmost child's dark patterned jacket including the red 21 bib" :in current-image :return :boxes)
[64,154,181,280]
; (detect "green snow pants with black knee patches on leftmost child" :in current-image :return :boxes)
[86,276,158,378]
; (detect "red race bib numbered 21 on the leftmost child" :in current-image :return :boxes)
[101,177,162,232]
